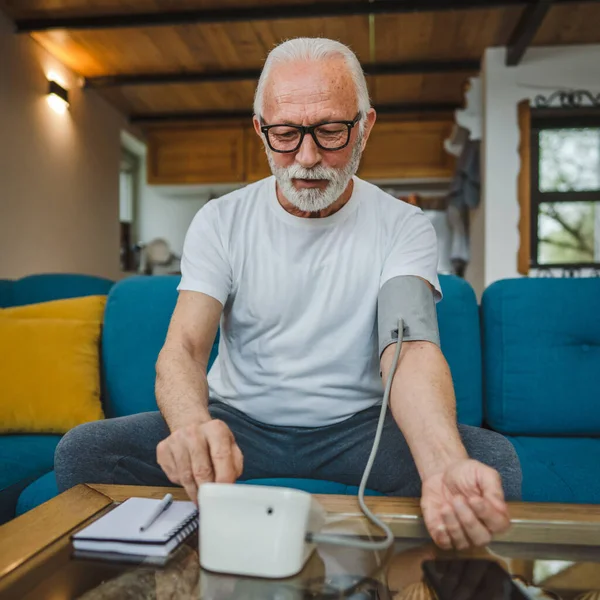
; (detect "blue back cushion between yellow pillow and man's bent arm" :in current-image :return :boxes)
[102,275,219,417]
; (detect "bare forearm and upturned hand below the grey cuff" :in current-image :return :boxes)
[381,316,509,549]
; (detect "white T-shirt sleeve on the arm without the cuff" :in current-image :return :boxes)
[177,202,232,306]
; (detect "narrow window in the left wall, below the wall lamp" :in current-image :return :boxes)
[119,148,140,271]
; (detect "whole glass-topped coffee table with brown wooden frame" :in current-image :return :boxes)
[0,485,600,600]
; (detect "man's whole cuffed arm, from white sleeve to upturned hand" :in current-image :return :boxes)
[378,211,509,548]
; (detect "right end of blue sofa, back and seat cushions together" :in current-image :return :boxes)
[481,278,600,504]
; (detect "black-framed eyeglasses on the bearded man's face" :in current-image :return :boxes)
[260,113,361,152]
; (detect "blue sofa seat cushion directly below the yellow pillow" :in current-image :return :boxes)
[0,434,61,490]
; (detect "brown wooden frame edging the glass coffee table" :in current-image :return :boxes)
[0,484,600,597]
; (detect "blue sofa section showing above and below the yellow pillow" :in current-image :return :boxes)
[0,274,113,523]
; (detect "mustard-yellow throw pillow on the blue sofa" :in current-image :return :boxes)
[0,296,106,433]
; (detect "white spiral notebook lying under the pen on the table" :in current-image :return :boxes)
[73,498,198,557]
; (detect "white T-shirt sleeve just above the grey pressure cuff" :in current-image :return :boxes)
[379,210,442,302]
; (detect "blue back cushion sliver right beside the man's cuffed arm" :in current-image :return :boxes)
[437,275,483,426]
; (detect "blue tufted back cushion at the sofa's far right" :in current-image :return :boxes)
[482,278,600,436]
